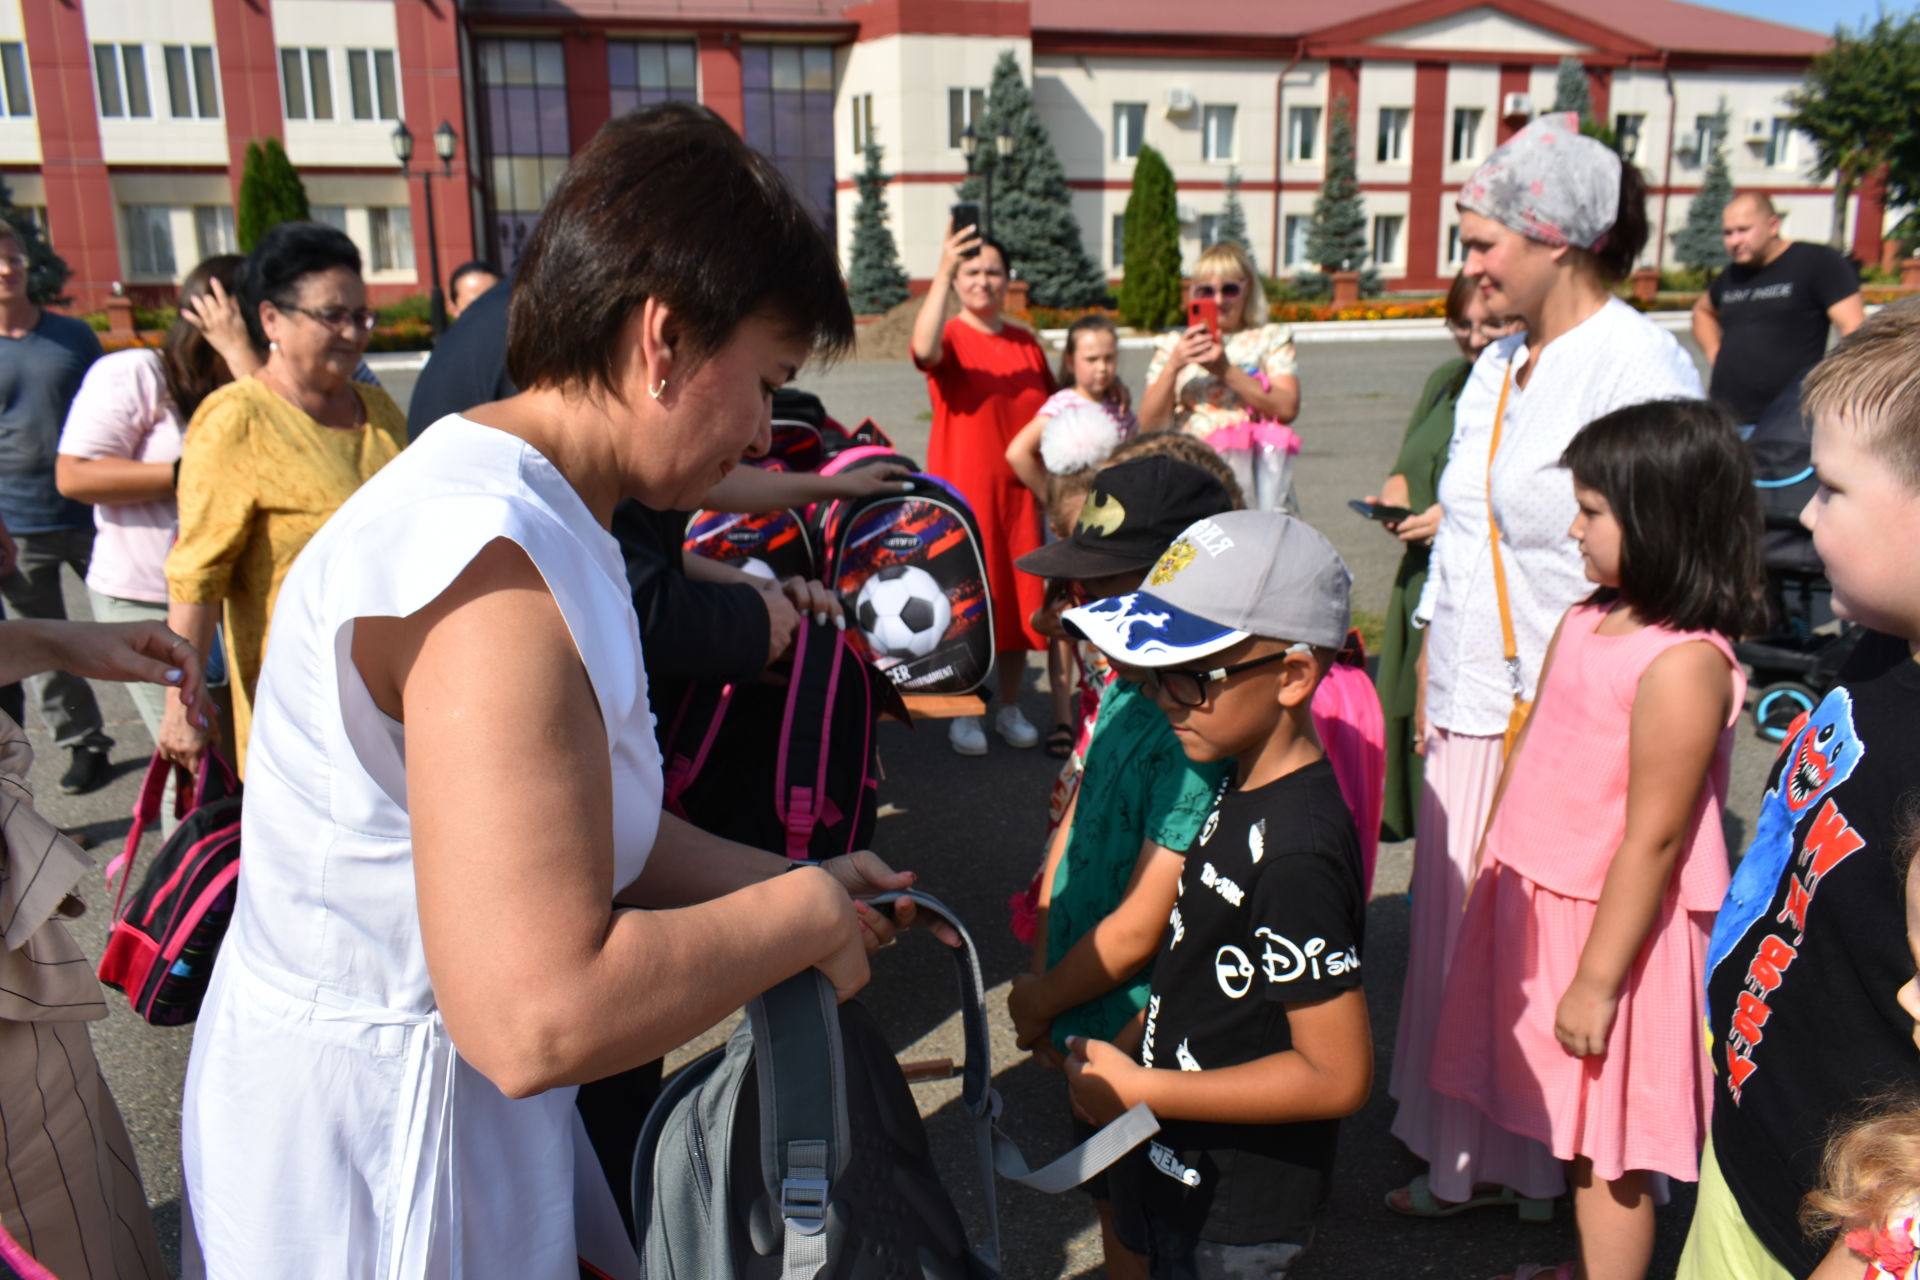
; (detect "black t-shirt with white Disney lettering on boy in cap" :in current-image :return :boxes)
[1121,760,1365,1244]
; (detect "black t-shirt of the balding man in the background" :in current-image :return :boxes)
[1707,242,1860,422]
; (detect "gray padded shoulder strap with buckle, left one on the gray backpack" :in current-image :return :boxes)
[747,969,852,1280]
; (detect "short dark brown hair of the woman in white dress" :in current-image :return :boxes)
[507,102,852,393]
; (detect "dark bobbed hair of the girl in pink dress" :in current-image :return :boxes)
[1561,399,1766,637]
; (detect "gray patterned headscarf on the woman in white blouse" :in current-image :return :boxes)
[1459,111,1620,253]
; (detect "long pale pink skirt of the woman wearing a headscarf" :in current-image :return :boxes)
[1388,729,1586,1199]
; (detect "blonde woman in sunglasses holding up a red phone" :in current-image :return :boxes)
[1140,240,1300,439]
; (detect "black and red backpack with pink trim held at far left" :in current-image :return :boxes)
[100,750,240,1027]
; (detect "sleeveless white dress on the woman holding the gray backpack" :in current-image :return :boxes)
[180,418,660,1280]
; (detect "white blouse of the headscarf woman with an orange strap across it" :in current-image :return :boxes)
[1415,297,1703,737]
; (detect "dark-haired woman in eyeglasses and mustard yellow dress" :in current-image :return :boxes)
[159,223,407,771]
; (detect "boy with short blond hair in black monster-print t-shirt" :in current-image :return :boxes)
[1678,301,1920,1280]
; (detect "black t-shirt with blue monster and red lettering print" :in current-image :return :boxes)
[1707,662,1920,1276]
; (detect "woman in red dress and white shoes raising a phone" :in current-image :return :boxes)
[914,226,1056,756]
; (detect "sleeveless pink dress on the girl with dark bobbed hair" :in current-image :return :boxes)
[1430,604,1745,1182]
